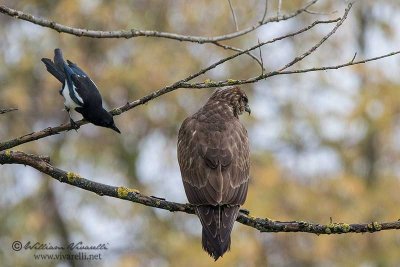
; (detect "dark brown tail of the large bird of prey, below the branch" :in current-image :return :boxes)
[196,205,239,260]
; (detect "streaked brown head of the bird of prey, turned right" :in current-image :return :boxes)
[210,86,251,117]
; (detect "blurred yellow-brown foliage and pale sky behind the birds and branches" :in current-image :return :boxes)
[0,0,400,266]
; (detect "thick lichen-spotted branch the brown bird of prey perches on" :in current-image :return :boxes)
[0,151,400,235]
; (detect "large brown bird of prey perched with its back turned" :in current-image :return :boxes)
[178,87,251,260]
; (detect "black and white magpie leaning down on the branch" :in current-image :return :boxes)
[42,48,121,133]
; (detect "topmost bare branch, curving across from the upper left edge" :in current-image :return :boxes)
[0,0,318,44]
